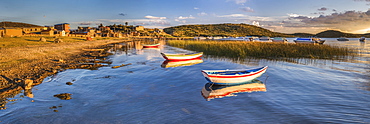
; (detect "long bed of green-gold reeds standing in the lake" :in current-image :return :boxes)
[167,40,353,59]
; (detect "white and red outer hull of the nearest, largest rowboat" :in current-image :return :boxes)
[202,66,268,85]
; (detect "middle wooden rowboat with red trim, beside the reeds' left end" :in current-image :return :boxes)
[161,52,203,60]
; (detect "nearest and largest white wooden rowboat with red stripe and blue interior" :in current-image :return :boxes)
[202,66,268,85]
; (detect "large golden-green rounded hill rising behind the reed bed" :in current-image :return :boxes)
[163,24,294,37]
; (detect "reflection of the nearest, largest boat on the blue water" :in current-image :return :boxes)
[201,79,266,101]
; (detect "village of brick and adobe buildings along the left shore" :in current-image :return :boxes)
[0,22,168,38]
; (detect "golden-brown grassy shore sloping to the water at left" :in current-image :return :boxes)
[0,39,129,90]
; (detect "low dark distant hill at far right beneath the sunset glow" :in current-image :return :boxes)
[315,30,370,38]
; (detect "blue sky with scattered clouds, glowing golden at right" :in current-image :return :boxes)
[0,0,370,34]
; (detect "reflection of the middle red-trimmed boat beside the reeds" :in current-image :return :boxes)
[161,58,203,68]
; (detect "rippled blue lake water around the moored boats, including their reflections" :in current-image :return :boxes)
[0,38,370,124]
